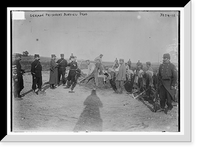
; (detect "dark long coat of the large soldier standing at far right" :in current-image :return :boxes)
[158,62,177,100]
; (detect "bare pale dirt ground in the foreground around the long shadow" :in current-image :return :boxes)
[12,71,178,132]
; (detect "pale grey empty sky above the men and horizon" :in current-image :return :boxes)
[12,11,178,62]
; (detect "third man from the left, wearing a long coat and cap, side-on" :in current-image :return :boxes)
[49,54,58,89]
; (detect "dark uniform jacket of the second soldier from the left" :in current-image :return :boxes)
[31,60,42,77]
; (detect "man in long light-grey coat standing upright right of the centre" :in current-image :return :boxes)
[116,59,126,93]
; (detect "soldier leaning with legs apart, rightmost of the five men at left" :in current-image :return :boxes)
[65,56,80,93]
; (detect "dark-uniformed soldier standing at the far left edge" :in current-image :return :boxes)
[12,54,24,98]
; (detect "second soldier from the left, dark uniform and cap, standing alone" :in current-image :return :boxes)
[31,54,42,94]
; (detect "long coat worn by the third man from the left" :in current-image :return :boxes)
[49,59,58,84]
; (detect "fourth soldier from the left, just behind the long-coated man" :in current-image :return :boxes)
[56,54,67,85]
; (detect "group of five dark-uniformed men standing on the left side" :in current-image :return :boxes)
[12,54,81,98]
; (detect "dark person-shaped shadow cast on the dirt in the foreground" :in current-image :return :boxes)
[74,90,103,132]
